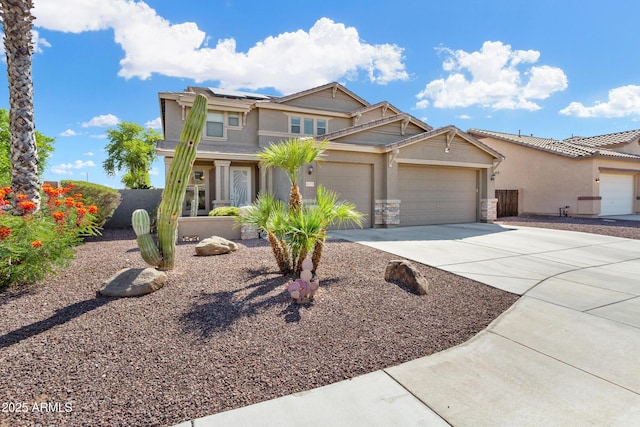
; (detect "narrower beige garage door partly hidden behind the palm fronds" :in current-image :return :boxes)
[316,162,373,228]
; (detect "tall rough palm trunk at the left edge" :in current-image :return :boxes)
[0,0,40,213]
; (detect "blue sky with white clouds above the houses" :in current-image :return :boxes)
[0,0,640,188]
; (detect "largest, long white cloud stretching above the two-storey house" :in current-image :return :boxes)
[34,0,408,94]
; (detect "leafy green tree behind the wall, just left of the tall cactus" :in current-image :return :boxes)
[102,122,162,188]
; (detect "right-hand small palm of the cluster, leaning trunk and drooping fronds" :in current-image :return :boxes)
[311,185,364,274]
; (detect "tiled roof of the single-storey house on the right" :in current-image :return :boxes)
[467,129,640,159]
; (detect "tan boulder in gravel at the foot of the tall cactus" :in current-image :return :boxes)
[99,267,169,297]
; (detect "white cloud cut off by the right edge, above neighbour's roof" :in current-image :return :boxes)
[560,85,640,117]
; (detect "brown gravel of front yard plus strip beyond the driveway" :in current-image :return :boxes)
[0,217,640,427]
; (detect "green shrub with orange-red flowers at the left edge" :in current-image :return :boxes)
[0,185,98,288]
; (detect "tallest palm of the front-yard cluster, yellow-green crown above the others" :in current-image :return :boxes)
[258,138,329,209]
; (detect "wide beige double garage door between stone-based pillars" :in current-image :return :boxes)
[398,165,478,226]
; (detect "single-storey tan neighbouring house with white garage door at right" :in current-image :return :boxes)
[467,129,640,217]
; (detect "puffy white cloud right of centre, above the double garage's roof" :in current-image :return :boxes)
[416,41,567,111]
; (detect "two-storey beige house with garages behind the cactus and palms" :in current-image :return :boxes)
[157,83,503,231]
